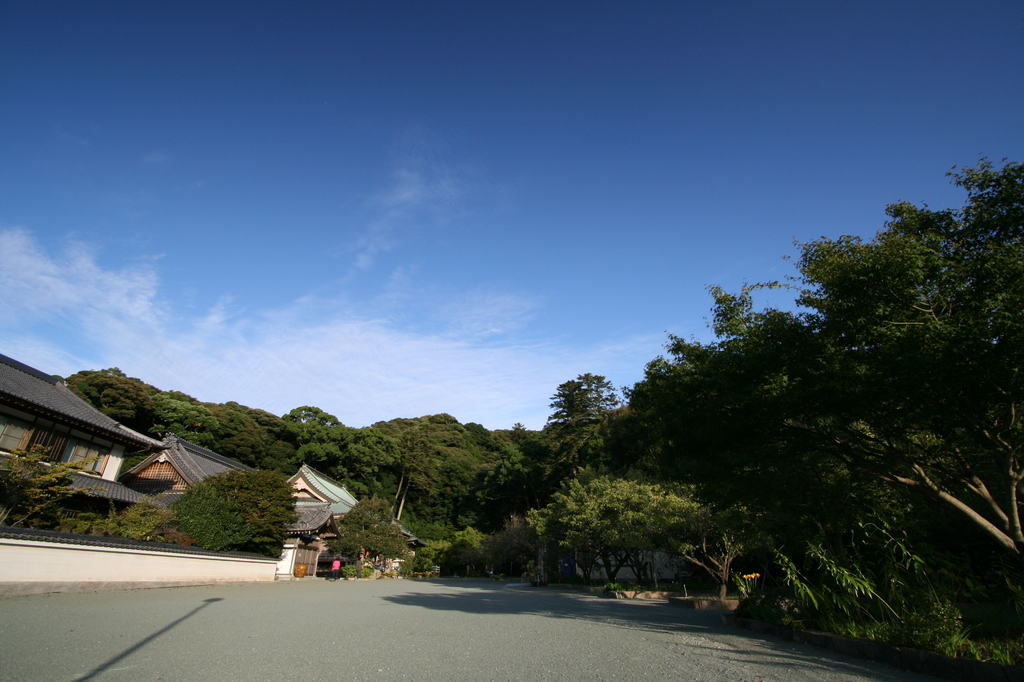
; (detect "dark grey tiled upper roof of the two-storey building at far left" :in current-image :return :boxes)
[0,355,160,449]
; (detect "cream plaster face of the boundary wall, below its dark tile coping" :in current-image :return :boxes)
[0,538,278,583]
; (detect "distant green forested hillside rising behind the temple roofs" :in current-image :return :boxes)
[67,368,627,539]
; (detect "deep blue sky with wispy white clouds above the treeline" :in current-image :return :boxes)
[0,0,1024,429]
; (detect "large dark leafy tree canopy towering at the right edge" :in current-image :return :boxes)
[633,161,1024,556]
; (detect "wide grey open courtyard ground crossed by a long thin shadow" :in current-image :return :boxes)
[0,580,933,682]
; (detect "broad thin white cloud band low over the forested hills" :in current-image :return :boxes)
[0,229,652,429]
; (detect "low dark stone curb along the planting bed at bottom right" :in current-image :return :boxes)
[722,614,1024,682]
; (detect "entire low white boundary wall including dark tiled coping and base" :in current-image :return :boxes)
[0,527,278,595]
